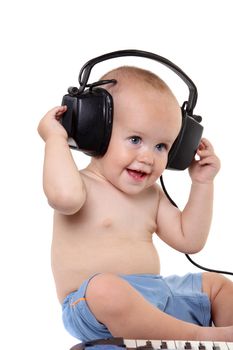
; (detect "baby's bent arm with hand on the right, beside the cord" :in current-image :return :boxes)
[157,139,220,253]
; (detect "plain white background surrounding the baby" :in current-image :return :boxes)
[0,0,233,350]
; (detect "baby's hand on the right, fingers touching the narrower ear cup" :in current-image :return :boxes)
[189,138,220,183]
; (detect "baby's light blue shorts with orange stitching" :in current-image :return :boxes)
[62,273,212,341]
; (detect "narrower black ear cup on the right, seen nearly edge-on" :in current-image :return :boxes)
[167,111,203,170]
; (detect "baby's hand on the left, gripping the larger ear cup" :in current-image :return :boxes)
[38,106,68,142]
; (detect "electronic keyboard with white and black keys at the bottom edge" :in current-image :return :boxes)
[70,338,233,350]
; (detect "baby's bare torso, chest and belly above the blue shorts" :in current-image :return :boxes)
[52,171,160,301]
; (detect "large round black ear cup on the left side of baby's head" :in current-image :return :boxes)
[61,88,113,156]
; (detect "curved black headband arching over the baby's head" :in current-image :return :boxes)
[78,50,197,115]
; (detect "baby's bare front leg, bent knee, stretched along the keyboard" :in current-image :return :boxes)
[86,274,233,341]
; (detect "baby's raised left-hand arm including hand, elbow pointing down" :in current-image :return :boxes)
[38,106,86,215]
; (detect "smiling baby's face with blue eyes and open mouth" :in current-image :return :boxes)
[92,84,181,194]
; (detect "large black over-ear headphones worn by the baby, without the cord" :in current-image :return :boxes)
[61,50,203,170]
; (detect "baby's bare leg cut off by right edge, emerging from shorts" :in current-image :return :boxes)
[202,272,233,327]
